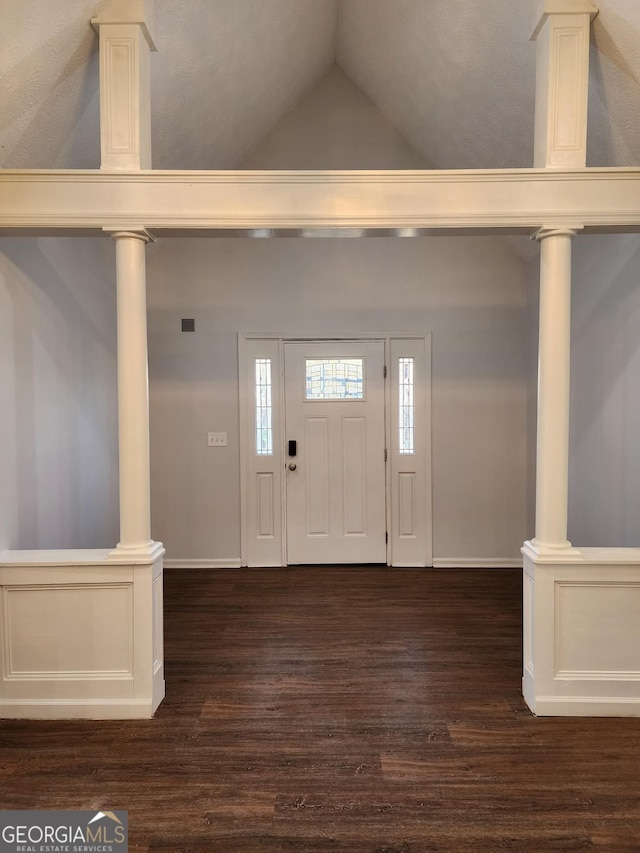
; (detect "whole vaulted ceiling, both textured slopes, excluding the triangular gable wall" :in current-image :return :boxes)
[0,0,640,169]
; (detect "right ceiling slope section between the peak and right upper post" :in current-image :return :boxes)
[337,0,535,169]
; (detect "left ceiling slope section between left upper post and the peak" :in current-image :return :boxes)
[152,0,338,169]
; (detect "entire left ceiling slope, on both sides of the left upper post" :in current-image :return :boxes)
[0,0,338,169]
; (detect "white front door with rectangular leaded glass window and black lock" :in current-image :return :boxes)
[284,341,386,564]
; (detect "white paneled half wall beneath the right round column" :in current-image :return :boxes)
[523,543,640,716]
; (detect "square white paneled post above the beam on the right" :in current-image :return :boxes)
[531,0,598,169]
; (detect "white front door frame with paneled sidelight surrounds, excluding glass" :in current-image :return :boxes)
[238,332,433,567]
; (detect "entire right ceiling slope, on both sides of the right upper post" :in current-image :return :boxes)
[337,0,640,169]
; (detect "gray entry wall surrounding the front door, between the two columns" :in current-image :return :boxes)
[148,237,527,559]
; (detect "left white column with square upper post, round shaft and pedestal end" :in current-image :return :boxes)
[92,0,164,716]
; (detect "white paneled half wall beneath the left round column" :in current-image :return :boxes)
[0,551,164,719]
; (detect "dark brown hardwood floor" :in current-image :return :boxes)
[0,567,640,853]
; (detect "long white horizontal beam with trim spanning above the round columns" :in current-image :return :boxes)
[0,168,640,236]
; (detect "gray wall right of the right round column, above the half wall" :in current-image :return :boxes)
[569,234,640,547]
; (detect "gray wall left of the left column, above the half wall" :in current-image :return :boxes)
[0,238,118,549]
